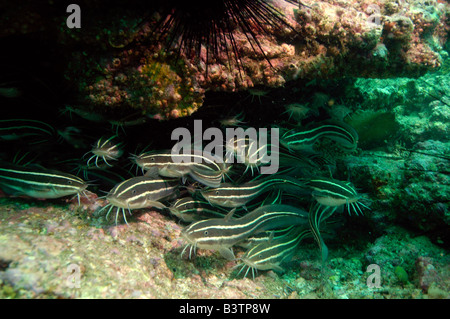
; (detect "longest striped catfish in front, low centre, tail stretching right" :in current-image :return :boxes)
[181,204,308,260]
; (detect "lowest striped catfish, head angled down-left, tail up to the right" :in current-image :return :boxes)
[237,226,311,279]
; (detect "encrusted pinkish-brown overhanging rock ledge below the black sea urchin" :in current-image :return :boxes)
[63,0,450,119]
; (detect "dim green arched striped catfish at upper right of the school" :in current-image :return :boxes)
[280,121,358,152]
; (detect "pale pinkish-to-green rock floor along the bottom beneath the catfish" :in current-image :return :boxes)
[0,198,450,299]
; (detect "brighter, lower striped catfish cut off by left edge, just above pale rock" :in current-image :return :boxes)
[0,162,88,202]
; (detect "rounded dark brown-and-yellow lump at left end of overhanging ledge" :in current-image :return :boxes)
[66,46,204,119]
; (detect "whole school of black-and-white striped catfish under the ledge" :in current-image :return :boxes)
[0,113,369,277]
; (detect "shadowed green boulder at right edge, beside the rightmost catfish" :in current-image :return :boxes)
[345,140,450,243]
